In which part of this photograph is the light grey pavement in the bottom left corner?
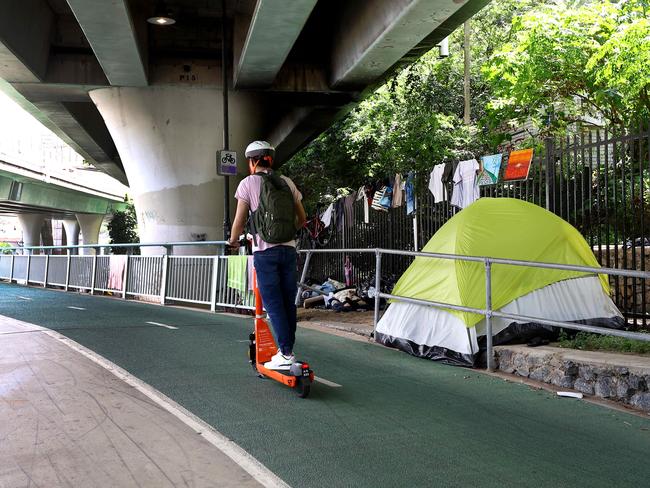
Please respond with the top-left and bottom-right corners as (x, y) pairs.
(0, 317), (268, 488)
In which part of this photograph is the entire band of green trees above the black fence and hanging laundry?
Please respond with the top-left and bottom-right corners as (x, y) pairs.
(285, 0), (650, 209)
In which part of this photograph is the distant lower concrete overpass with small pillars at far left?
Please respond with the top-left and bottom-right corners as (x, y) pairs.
(0, 161), (125, 252)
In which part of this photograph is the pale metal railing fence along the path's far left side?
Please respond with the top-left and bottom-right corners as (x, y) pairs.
(0, 241), (255, 311)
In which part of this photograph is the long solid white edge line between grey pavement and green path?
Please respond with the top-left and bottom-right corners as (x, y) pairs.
(36, 324), (291, 488)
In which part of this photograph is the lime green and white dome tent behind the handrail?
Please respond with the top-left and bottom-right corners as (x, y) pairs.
(377, 198), (620, 366)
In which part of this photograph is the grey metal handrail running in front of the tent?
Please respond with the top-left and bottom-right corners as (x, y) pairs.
(296, 248), (650, 371)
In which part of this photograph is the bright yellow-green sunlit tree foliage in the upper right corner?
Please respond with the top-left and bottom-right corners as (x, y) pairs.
(483, 0), (650, 131)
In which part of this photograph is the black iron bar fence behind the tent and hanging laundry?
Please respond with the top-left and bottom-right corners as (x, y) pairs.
(299, 127), (650, 326)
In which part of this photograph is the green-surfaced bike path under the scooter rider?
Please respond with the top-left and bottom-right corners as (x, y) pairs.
(0, 284), (650, 488)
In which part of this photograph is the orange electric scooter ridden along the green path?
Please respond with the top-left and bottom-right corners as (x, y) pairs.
(248, 268), (314, 398)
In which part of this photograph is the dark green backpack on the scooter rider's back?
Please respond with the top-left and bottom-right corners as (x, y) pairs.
(251, 172), (296, 244)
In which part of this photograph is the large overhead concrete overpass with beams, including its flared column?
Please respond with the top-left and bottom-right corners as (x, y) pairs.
(0, 0), (489, 250)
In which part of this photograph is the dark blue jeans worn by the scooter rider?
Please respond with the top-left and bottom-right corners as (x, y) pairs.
(253, 246), (298, 354)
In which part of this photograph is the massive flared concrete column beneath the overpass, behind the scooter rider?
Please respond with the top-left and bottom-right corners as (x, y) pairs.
(90, 85), (264, 254)
